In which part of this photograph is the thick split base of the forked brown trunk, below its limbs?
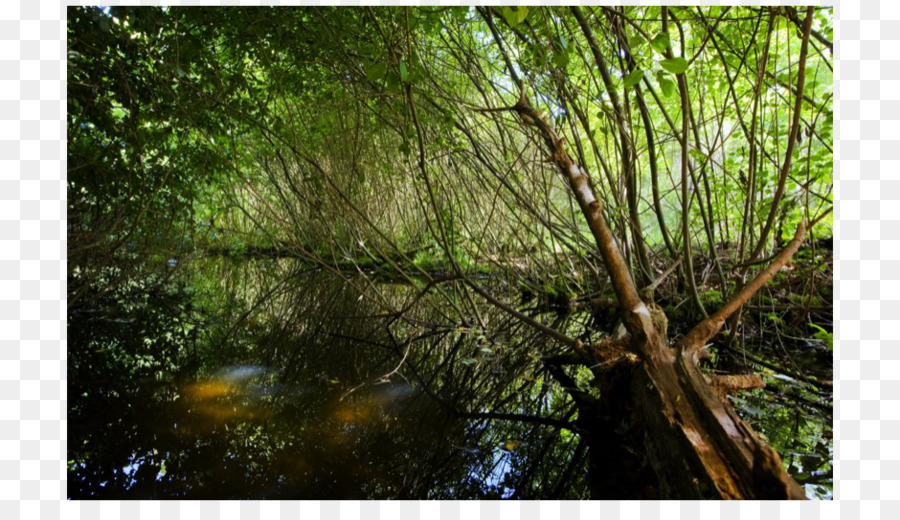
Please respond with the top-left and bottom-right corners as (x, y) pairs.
(582, 335), (805, 500)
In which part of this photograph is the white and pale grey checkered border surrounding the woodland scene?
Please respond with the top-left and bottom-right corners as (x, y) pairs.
(0, 0), (864, 520)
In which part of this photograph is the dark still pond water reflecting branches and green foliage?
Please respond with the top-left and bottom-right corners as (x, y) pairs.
(68, 259), (831, 499)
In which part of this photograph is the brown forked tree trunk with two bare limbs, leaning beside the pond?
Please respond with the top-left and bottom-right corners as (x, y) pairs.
(510, 85), (805, 499)
